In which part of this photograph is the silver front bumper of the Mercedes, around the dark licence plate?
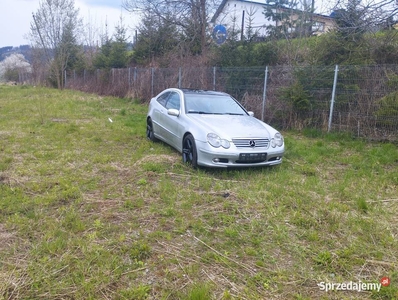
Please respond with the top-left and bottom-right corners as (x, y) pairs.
(196, 141), (284, 168)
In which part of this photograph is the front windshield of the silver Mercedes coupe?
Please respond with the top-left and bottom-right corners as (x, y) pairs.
(185, 94), (247, 115)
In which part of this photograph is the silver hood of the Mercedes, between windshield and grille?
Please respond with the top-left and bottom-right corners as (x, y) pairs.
(188, 114), (271, 139)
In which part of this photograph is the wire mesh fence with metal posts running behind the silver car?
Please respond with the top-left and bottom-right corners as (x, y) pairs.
(65, 65), (398, 141)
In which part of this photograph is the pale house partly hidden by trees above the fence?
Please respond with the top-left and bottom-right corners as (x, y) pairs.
(210, 0), (335, 39)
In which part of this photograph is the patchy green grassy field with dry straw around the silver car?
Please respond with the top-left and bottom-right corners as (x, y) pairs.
(0, 86), (398, 299)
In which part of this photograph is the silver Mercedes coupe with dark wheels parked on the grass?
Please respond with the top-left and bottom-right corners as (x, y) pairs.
(146, 88), (284, 167)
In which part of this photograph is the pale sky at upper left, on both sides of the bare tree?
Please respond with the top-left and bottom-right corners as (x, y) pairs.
(0, 0), (137, 48)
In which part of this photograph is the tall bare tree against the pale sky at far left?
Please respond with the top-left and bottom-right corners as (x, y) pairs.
(30, 0), (82, 88)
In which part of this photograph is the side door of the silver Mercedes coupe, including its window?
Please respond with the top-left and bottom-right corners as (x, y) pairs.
(162, 92), (181, 149)
